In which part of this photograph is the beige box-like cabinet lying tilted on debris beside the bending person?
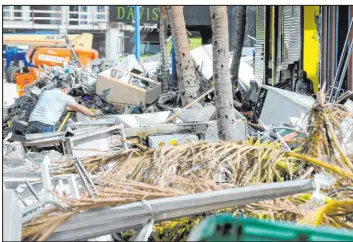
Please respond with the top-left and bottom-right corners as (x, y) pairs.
(96, 67), (161, 106)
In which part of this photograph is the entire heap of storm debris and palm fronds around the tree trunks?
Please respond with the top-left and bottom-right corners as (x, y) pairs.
(3, 42), (353, 241)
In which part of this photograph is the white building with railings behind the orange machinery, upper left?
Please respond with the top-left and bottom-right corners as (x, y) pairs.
(3, 6), (109, 56)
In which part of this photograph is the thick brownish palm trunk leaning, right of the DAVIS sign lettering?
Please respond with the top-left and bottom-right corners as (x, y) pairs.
(167, 6), (199, 106)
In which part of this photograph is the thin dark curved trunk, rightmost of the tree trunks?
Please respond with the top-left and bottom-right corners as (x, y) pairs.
(231, 6), (246, 88)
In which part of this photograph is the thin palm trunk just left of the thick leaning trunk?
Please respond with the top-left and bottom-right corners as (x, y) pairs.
(159, 6), (170, 93)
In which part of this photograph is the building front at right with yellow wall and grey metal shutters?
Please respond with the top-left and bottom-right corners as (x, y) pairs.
(254, 6), (353, 91)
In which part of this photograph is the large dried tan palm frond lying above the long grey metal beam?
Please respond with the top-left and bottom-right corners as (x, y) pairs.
(99, 141), (353, 187)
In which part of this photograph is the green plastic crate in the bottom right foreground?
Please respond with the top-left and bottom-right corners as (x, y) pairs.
(188, 214), (353, 241)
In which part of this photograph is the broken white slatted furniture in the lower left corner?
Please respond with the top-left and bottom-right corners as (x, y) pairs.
(3, 156), (85, 238)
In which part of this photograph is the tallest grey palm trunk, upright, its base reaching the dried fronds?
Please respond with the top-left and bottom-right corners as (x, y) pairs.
(211, 6), (236, 140)
